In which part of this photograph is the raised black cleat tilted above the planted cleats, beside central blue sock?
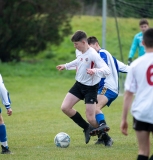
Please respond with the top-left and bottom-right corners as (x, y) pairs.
(90, 124), (110, 136)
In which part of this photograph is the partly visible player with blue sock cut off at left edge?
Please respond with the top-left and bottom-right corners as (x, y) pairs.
(0, 75), (12, 154)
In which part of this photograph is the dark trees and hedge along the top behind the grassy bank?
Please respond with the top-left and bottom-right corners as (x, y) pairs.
(0, 0), (153, 62)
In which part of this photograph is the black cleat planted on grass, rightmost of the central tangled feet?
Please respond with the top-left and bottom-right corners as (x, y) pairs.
(95, 132), (113, 147)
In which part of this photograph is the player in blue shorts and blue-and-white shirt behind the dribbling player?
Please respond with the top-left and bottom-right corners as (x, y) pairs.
(88, 36), (129, 146)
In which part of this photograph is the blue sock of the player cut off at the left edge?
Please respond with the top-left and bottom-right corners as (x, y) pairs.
(0, 124), (8, 148)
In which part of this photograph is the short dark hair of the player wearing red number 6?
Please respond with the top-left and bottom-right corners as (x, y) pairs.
(143, 28), (153, 48)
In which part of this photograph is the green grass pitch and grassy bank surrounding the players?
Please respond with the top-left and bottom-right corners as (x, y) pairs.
(0, 16), (152, 160)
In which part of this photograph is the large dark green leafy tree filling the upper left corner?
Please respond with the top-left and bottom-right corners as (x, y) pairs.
(0, 0), (80, 62)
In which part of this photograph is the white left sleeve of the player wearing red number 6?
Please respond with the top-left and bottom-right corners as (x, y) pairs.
(124, 67), (137, 93)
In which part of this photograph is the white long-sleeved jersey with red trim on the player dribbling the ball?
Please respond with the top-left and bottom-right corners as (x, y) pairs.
(65, 47), (110, 86)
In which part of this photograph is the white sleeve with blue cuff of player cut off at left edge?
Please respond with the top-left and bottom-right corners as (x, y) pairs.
(0, 74), (11, 109)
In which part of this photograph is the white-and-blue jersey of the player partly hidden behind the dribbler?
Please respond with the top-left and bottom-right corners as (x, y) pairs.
(98, 49), (129, 94)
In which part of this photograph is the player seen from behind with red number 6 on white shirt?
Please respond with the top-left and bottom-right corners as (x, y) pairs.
(121, 28), (153, 160)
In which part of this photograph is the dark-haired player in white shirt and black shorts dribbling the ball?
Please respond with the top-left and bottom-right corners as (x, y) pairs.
(56, 31), (110, 144)
